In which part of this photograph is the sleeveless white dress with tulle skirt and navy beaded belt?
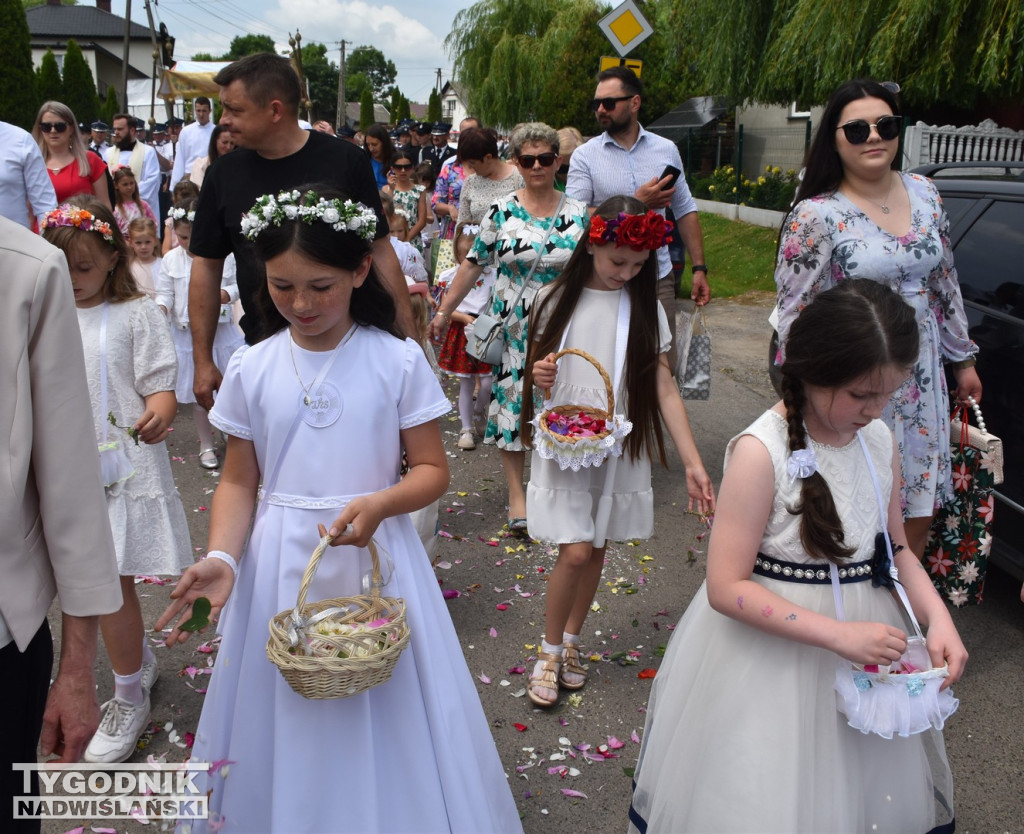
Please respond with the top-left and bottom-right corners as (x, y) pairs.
(629, 411), (952, 834)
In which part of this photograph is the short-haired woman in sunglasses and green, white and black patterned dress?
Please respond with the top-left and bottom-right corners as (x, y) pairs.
(430, 122), (587, 535)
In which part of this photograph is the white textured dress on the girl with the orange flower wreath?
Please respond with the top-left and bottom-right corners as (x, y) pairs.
(78, 298), (193, 576)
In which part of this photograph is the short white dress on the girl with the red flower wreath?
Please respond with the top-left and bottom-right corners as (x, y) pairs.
(526, 287), (672, 544)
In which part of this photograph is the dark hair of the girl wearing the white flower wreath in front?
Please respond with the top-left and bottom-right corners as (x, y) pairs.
(254, 183), (402, 340)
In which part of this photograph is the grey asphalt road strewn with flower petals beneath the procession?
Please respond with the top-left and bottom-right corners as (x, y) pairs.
(37, 295), (1024, 834)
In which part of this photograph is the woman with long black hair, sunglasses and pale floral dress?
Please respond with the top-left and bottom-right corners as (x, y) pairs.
(775, 80), (981, 569)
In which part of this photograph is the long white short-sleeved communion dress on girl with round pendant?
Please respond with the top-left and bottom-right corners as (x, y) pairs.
(193, 327), (521, 834)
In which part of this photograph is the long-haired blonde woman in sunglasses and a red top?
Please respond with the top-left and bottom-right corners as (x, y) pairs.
(32, 101), (111, 208)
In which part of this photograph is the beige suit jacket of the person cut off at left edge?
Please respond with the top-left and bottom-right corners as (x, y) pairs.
(0, 217), (121, 651)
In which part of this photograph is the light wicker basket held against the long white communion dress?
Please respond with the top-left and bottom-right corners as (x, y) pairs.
(266, 536), (411, 699)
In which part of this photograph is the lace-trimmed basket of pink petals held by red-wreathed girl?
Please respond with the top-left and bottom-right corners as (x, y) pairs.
(534, 347), (633, 471)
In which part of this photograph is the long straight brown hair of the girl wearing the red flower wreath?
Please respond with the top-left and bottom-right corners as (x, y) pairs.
(520, 196), (666, 465)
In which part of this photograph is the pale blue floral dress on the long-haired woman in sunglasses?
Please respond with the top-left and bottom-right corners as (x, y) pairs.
(775, 173), (978, 518)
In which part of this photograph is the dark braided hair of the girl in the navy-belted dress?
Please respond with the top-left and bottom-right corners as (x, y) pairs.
(781, 280), (920, 561)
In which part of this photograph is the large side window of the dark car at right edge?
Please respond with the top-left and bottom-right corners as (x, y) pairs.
(946, 198), (1024, 309)
